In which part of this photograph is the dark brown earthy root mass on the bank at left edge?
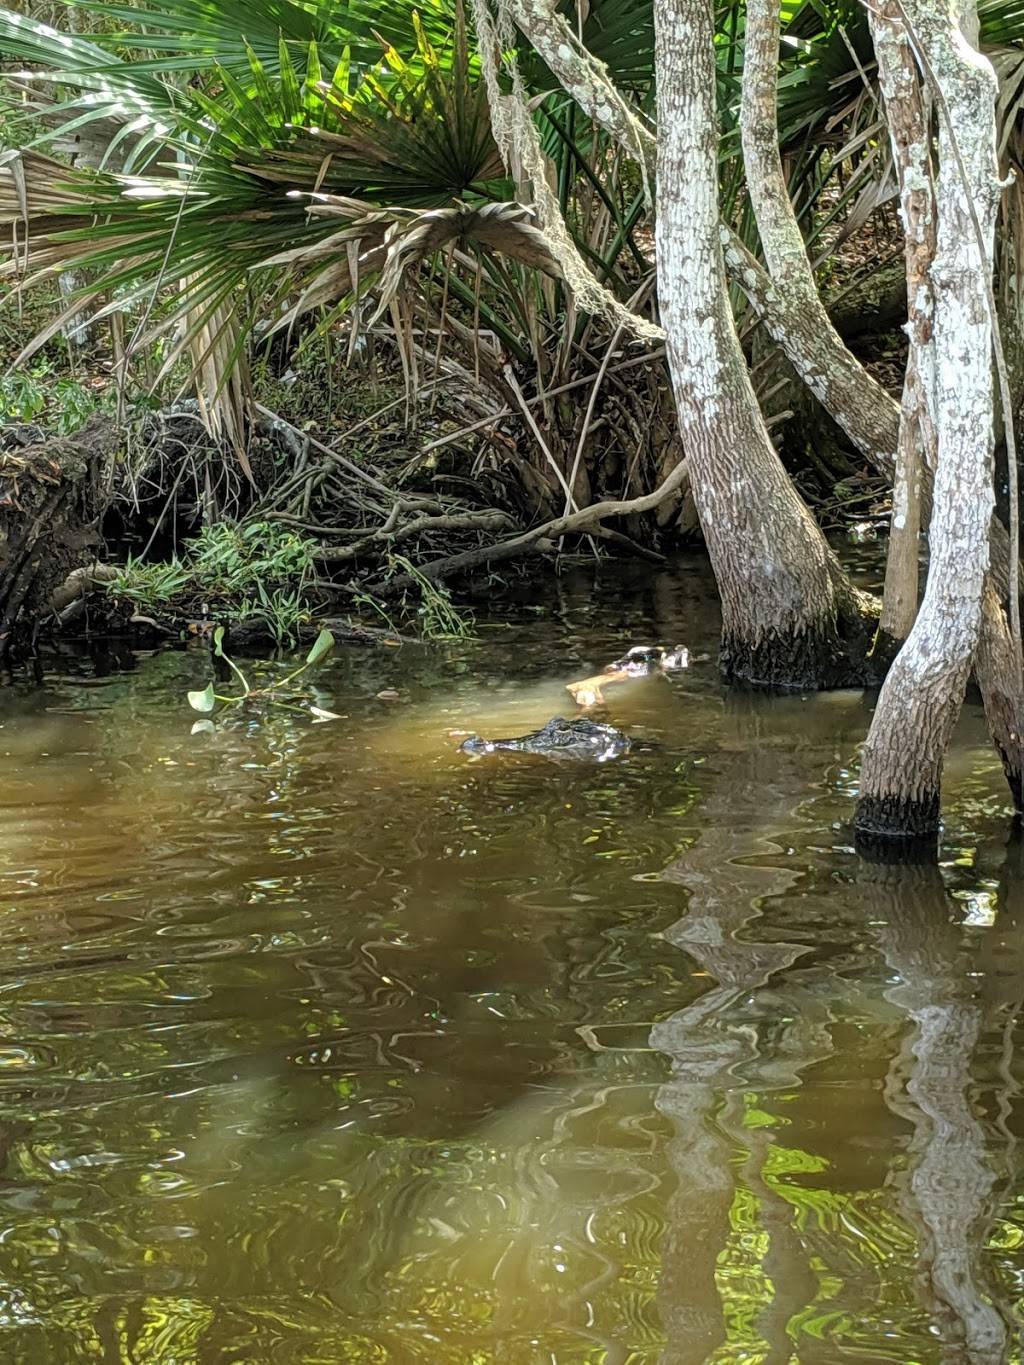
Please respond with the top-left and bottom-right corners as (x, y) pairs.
(0, 414), (119, 658)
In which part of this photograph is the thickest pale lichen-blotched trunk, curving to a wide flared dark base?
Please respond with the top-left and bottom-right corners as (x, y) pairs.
(654, 0), (867, 687)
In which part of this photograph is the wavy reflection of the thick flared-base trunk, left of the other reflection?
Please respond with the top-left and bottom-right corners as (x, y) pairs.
(651, 745), (831, 1365)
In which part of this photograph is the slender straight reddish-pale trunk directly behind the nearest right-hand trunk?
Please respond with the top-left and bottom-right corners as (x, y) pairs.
(868, 0), (935, 655)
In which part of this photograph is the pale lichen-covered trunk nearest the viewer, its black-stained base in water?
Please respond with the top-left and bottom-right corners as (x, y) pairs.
(855, 0), (999, 837)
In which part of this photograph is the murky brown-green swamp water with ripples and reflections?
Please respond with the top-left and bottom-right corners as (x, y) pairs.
(0, 564), (1024, 1365)
